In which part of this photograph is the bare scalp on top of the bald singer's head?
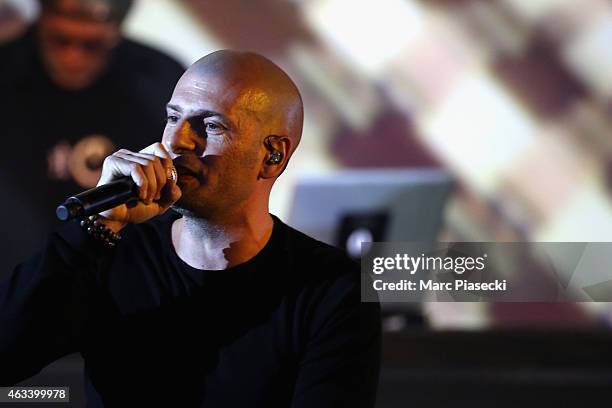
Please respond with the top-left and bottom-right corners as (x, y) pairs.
(181, 50), (304, 154)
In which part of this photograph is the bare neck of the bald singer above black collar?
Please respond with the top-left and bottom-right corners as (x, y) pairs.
(172, 212), (274, 270)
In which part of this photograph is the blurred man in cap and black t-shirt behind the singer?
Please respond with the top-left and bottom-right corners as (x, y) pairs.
(0, 0), (184, 278)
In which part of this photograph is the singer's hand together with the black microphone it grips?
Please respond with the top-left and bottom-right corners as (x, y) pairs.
(57, 143), (181, 231)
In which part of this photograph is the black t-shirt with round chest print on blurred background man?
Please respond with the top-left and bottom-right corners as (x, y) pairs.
(0, 30), (184, 278)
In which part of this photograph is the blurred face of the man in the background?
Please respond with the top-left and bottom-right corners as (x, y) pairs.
(39, 14), (120, 90)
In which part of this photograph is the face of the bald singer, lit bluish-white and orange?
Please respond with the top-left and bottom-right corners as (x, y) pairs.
(163, 72), (266, 217)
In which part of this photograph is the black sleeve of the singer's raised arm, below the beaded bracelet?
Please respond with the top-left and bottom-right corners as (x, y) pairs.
(0, 222), (112, 386)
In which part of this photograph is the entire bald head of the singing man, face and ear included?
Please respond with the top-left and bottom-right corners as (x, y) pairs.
(162, 51), (304, 218)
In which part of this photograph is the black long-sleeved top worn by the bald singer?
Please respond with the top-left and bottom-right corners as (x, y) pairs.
(0, 212), (380, 408)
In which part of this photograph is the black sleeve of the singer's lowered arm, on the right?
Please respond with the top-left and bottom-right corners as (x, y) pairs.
(293, 262), (381, 408)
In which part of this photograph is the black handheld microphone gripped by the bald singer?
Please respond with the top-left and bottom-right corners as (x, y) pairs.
(55, 166), (178, 221)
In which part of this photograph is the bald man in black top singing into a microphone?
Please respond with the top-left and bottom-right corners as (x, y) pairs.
(0, 51), (380, 408)
